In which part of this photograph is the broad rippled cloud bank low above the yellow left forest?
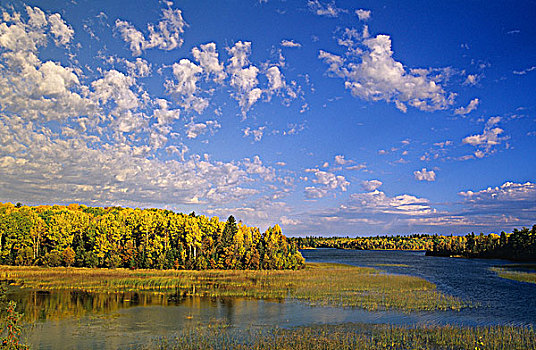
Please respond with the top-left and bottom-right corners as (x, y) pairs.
(0, 115), (271, 206)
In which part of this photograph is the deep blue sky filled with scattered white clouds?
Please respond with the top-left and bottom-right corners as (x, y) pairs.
(0, 0), (536, 236)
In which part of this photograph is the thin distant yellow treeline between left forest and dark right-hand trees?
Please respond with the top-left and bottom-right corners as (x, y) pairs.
(291, 234), (437, 250)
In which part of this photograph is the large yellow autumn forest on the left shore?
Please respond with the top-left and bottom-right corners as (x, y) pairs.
(0, 203), (304, 270)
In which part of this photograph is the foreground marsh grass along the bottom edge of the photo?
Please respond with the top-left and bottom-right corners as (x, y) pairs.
(142, 323), (536, 350)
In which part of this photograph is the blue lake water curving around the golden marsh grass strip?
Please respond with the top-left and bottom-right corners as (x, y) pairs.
(8, 249), (536, 349)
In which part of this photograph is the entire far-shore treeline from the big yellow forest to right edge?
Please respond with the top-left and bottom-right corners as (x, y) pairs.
(291, 225), (536, 261)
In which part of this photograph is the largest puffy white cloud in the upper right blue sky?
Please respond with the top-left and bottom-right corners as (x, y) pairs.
(319, 35), (454, 112)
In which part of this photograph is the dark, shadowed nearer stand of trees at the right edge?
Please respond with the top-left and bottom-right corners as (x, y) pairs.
(426, 225), (536, 261)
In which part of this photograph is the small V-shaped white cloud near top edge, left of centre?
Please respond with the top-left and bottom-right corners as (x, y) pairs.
(115, 3), (187, 56)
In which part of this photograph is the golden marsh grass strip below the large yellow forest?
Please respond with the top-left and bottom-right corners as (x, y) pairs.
(0, 263), (467, 311)
